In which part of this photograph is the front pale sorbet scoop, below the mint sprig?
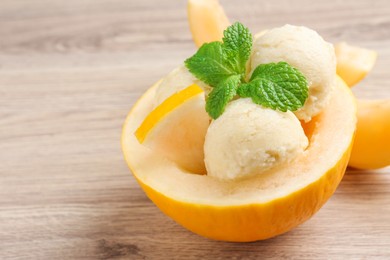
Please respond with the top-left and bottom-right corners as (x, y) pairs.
(204, 98), (308, 180)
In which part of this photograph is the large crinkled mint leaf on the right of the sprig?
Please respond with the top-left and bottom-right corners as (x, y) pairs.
(238, 62), (308, 112)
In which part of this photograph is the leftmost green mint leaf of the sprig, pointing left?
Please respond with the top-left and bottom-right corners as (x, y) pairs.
(184, 42), (236, 87)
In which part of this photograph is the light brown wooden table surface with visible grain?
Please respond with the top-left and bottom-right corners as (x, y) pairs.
(0, 0), (390, 259)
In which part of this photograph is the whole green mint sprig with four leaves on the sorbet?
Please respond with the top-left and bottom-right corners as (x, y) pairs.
(185, 22), (308, 119)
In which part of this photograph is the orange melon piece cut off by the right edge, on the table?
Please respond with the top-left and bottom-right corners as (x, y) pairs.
(349, 99), (390, 169)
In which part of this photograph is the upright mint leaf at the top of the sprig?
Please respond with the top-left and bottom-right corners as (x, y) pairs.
(223, 22), (252, 78)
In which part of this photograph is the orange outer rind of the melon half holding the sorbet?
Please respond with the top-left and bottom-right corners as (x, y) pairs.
(134, 146), (352, 242)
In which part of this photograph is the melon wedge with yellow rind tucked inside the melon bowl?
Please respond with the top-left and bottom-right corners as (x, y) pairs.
(134, 84), (210, 174)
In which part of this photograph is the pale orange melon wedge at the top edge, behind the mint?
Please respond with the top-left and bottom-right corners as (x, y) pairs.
(187, 0), (230, 47)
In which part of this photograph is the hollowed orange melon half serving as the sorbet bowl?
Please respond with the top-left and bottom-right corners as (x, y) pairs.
(122, 75), (356, 242)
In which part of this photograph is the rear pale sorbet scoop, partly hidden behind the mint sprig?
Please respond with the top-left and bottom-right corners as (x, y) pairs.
(250, 25), (336, 121)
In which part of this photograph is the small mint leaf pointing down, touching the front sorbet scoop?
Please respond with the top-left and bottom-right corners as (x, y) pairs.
(206, 75), (240, 119)
